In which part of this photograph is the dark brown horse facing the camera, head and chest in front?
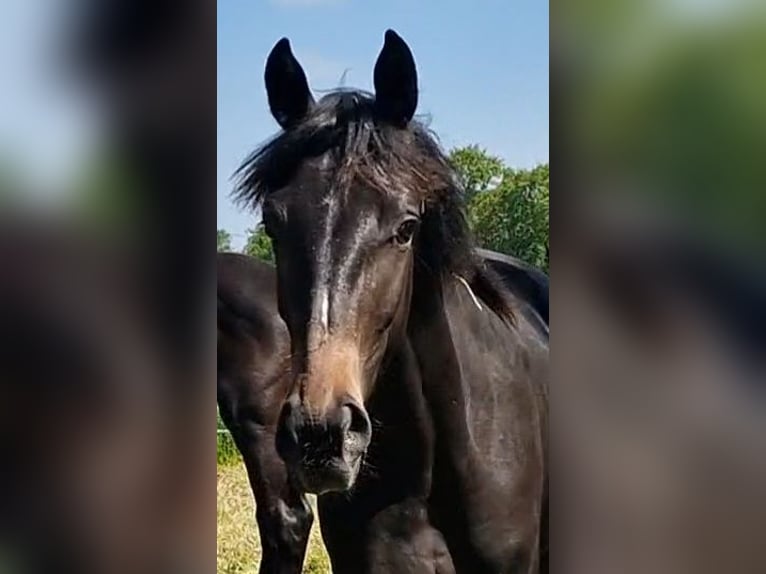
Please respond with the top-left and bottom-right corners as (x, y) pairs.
(230, 30), (548, 574)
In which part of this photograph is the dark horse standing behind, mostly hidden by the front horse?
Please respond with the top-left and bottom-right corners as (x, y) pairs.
(217, 249), (548, 574)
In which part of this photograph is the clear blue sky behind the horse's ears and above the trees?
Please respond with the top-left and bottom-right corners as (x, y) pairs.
(217, 0), (548, 247)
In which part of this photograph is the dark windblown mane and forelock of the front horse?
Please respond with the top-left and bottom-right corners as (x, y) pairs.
(233, 89), (514, 322)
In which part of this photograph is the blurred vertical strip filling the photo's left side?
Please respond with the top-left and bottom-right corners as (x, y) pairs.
(0, 0), (216, 574)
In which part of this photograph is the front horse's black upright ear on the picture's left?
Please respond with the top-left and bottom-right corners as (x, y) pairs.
(264, 38), (314, 129)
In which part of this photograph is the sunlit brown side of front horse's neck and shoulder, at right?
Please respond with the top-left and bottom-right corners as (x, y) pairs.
(428, 284), (548, 573)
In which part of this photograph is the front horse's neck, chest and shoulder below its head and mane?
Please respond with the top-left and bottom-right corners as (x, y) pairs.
(319, 272), (547, 574)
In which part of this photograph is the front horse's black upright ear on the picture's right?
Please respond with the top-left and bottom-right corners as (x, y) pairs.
(373, 30), (418, 127)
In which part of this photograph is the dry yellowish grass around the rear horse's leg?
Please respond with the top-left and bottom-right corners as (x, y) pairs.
(217, 452), (331, 574)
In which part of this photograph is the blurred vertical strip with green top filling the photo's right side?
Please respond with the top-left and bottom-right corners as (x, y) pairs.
(551, 0), (766, 574)
